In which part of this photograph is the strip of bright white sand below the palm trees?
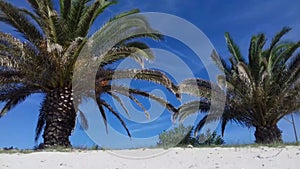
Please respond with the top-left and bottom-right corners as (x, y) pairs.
(0, 146), (300, 169)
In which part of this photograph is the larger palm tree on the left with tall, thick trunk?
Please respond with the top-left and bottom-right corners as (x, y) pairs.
(0, 0), (176, 147)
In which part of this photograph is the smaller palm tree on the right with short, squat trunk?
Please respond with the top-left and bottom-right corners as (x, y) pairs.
(175, 27), (300, 143)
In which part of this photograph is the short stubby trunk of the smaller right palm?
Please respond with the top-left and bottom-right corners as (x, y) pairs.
(254, 125), (282, 144)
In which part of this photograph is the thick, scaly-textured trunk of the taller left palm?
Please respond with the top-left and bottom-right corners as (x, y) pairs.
(43, 88), (76, 147)
